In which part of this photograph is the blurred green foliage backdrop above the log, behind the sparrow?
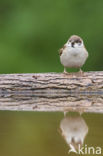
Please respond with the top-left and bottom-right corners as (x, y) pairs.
(0, 0), (103, 73)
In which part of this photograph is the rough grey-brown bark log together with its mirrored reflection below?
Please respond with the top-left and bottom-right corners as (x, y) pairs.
(0, 72), (103, 113)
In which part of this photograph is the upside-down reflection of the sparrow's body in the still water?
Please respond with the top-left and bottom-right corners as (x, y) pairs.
(60, 116), (88, 152)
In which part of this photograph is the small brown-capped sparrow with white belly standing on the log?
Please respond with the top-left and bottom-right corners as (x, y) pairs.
(59, 35), (88, 73)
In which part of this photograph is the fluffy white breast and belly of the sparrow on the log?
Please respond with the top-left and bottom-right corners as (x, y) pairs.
(60, 47), (88, 68)
